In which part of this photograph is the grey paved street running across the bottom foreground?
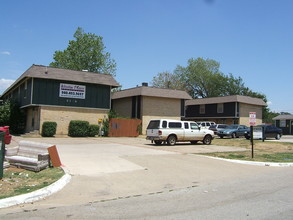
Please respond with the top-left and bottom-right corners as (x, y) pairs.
(8, 168), (293, 220)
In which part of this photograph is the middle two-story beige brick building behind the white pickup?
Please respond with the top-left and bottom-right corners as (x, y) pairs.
(112, 83), (191, 134)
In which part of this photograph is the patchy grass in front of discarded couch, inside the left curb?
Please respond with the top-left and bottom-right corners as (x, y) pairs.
(0, 167), (64, 199)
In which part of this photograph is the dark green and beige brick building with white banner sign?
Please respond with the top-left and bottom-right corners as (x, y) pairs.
(1, 65), (119, 135)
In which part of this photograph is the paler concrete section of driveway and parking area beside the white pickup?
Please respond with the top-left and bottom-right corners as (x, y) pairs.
(8, 137), (243, 176)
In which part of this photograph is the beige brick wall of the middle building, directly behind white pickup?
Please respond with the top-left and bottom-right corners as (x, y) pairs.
(141, 96), (181, 134)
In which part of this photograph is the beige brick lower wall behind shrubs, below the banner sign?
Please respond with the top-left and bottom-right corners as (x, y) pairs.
(40, 106), (109, 135)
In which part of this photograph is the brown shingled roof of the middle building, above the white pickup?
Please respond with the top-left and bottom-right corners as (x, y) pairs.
(112, 86), (192, 99)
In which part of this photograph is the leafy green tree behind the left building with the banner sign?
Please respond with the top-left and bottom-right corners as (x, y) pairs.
(50, 27), (116, 76)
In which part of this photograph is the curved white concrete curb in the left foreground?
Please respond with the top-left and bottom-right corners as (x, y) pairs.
(0, 168), (71, 209)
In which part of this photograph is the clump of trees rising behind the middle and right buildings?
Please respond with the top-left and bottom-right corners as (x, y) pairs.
(152, 58), (274, 122)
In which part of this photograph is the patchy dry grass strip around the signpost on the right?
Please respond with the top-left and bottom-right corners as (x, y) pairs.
(204, 138), (293, 163)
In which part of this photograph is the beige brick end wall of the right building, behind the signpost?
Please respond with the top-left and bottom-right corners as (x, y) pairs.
(239, 103), (262, 126)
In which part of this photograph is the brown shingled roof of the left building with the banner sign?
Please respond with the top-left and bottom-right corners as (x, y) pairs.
(3, 64), (120, 94)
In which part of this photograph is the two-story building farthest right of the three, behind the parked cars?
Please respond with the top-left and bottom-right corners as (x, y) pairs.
(185, 95), (266, 125)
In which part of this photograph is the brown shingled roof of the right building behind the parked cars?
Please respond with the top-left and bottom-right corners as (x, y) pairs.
(185, 95), (267, 106)
